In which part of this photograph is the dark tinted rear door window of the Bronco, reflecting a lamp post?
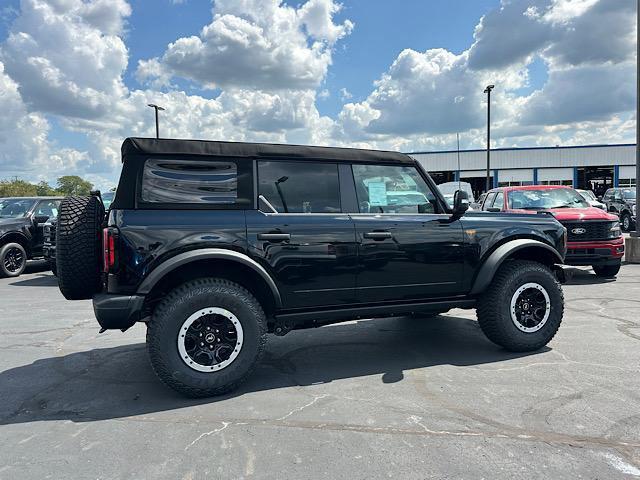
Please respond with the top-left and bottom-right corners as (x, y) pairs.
(258, 162), (340, 213)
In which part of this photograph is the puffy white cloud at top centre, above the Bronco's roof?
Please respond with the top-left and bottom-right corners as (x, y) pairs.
(137, 0), (353, 90)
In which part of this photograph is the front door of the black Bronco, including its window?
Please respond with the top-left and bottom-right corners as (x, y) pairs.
(352, 164), (464, 303)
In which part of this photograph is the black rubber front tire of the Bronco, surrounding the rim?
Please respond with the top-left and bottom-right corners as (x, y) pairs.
(477, 260), (564, 352)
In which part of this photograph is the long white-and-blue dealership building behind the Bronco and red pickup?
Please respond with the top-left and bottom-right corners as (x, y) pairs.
(409, 144), (636, 198)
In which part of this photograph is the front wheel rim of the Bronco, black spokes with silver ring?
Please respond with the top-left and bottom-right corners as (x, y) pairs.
(509, 282), (551, 333)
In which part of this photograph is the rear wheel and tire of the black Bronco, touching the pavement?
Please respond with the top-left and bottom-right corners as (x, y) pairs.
(147, 278), (267, 398)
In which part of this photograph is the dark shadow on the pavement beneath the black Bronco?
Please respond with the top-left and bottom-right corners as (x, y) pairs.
(0, 315), (550, 425)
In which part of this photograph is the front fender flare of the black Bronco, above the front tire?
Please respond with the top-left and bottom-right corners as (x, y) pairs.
(469, 238), (563, 295)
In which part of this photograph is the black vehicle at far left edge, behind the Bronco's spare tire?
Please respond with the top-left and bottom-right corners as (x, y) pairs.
(0, 197), (62, 277)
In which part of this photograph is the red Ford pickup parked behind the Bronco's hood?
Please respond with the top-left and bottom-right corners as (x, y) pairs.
(482, 185), (624, 278)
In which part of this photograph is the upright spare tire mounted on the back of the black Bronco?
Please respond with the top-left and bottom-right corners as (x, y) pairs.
(56, 196), (104, 300)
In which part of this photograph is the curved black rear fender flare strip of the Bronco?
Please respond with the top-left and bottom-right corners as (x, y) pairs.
(136, 248), (282, 308)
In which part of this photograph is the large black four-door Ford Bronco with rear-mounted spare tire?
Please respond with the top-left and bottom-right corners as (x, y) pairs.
(57, 138), (566, 397)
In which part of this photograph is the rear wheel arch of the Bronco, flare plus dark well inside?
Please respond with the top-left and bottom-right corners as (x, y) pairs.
(137, 248), (282, 315)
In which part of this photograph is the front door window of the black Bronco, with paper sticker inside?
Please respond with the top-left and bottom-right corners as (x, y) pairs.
(353, 165), (436, 213)
